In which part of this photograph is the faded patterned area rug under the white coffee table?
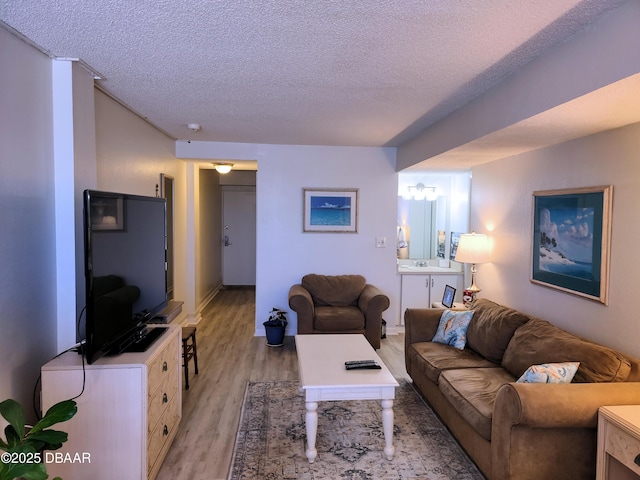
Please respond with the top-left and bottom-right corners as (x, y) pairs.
(229, 381), (484, 480)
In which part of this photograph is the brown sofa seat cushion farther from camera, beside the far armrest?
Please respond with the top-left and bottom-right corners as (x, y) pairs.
(408, 342), (495, 383)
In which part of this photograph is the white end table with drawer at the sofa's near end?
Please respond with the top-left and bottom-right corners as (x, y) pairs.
(596, 405), (640, 480)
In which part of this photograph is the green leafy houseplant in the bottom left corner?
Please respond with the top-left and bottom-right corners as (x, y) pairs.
(0, 399), (78, 480)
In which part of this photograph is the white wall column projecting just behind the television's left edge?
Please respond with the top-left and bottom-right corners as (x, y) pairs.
(51, 60), (96, 352)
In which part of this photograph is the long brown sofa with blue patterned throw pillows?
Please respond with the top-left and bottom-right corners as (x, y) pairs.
(405, 299), (640, 480)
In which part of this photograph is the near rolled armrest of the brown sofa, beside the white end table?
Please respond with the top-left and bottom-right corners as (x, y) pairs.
(491, 382), (640, 480)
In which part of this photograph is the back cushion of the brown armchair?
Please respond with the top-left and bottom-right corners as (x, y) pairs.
(301, 274), (367, 307)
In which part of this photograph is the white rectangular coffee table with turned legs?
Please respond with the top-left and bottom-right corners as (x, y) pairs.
(295, 334), (398, 463)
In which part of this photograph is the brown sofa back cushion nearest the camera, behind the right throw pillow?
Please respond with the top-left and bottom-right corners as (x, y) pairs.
(502, 319), (631, 383)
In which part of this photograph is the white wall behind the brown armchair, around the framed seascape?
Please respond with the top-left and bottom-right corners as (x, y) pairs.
(176, 142), (400, 335)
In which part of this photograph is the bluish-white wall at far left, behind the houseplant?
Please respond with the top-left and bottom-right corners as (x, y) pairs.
(0, 28), (57, 408)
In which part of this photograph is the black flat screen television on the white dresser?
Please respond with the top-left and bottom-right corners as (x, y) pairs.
(84, 190), (167, 363)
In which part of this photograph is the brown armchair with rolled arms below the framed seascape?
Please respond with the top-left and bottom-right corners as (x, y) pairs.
(289, 274), (389, 348)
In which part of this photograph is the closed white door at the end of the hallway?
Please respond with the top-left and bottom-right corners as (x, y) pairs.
(222, 187), (256, 285)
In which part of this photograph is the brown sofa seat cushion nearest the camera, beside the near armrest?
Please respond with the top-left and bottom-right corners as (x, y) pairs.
(438, 367), (515, 440)
